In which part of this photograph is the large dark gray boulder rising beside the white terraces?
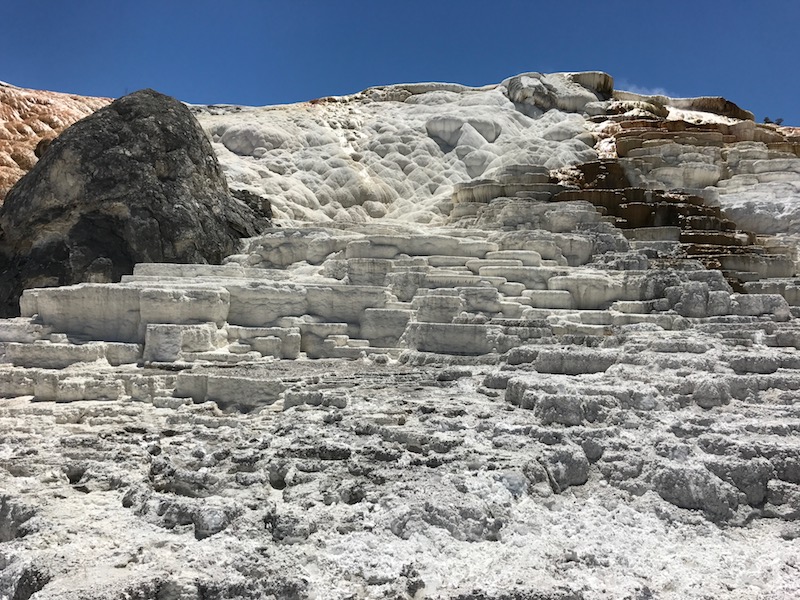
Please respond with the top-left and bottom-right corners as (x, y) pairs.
(0, 90), (271, 316)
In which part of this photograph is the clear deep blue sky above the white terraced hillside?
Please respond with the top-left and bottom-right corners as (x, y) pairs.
(0, 0), (800, 125)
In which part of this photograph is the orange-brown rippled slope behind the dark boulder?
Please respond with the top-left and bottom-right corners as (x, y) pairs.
(0, 83), (111, 203)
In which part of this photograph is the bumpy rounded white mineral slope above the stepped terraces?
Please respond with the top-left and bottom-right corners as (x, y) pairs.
(197, 73), (611, 223)
